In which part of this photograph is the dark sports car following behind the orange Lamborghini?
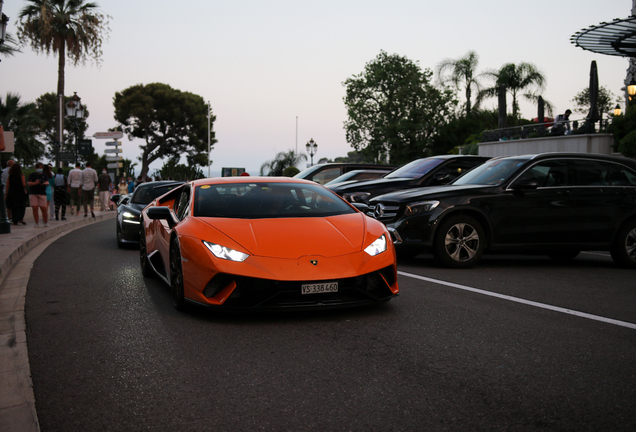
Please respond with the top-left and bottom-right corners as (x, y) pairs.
(110, 181), (183, 247)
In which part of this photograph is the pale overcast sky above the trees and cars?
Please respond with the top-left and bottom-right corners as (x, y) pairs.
(0, 0), (632, 175)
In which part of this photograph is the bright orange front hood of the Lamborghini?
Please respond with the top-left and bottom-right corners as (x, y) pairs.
(201, 213), (366, 259)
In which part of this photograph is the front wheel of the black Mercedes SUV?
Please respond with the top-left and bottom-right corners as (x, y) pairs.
(433, 215), (486, 268)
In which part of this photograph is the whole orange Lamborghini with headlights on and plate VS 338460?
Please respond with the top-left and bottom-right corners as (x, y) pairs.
(140, 177), (399, 309)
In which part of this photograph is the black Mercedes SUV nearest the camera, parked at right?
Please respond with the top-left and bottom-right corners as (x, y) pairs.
(368, 153), (636, 268)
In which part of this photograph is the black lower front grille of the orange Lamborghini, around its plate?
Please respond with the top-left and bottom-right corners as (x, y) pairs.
(203, 266), (396, 309)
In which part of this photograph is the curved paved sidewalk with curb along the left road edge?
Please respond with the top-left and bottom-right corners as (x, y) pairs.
(0, 207), (117, 432)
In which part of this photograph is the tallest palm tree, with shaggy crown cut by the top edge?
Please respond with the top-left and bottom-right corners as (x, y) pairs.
(18, 0), (110, 145)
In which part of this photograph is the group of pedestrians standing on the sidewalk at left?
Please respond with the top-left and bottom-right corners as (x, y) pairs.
(2, 160), (112, 227)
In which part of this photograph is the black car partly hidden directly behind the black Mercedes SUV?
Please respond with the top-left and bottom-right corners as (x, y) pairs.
(327, 155), (490, 203)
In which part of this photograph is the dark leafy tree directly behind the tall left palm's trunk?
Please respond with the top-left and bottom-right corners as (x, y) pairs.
(35, 93), (89, 163)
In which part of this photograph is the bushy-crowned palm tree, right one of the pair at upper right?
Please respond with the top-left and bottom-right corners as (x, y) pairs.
(477, 62), (546, 118)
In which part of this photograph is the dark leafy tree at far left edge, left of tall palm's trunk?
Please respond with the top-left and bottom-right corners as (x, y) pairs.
(0, 93), (44, 166)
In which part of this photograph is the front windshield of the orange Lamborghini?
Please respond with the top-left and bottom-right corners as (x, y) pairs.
(193, 182), (355, 219)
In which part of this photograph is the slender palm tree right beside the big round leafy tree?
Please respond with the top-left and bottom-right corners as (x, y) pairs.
(436, 51), (484, 116)
